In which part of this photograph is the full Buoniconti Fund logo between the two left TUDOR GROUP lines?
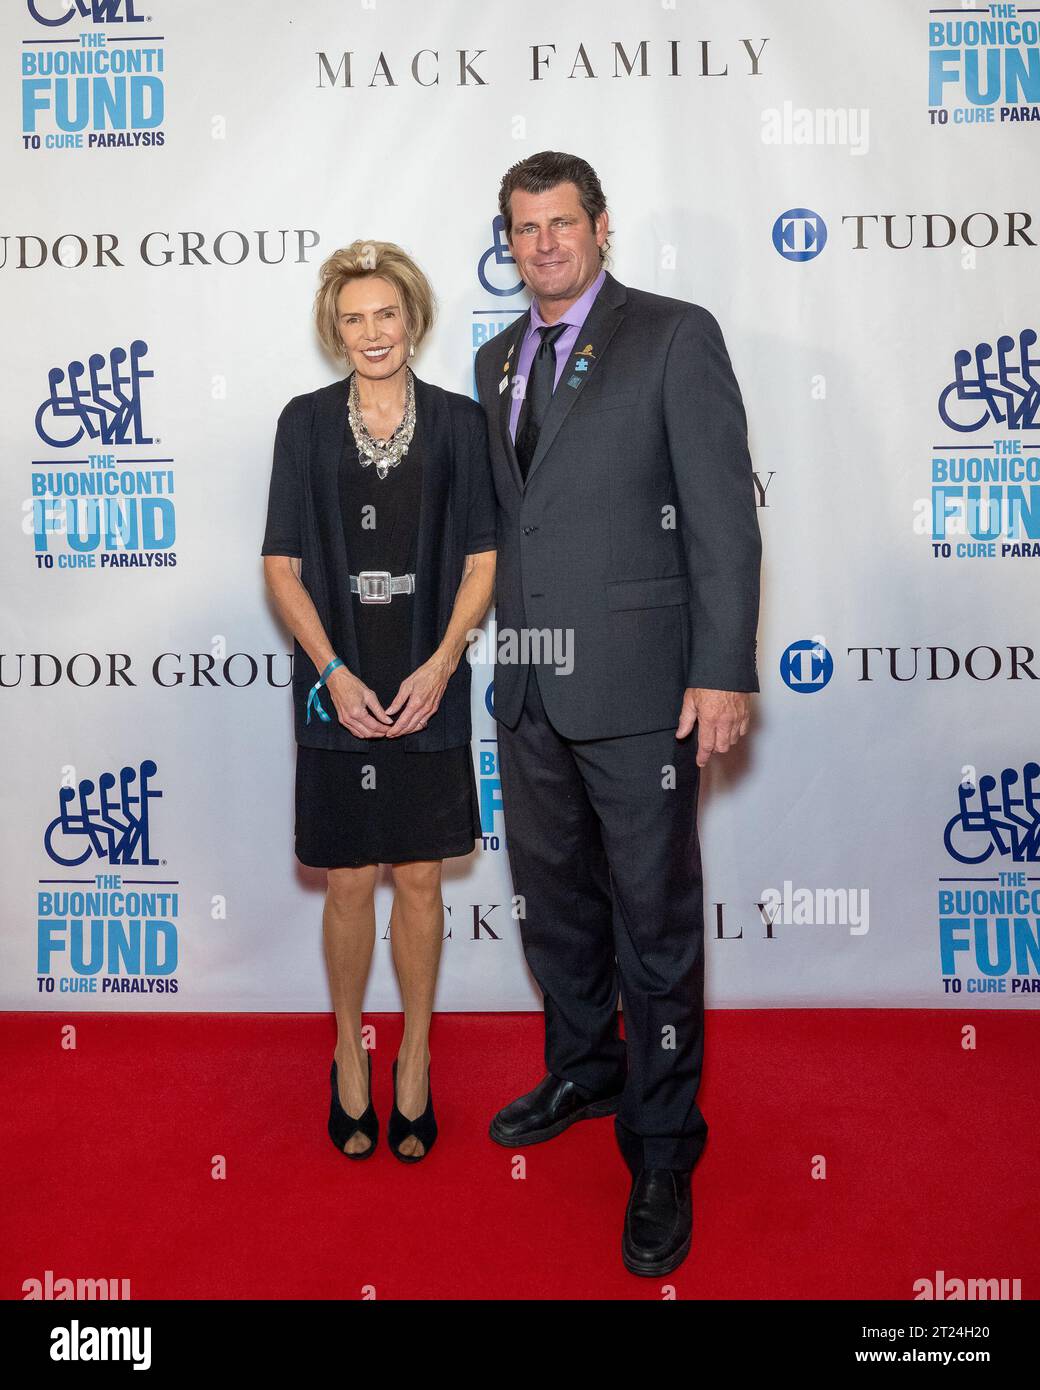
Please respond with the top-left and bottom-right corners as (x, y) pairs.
(25, 339), (177, 574)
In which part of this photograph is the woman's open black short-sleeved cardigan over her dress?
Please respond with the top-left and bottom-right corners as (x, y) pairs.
(260, 377), (495, 753)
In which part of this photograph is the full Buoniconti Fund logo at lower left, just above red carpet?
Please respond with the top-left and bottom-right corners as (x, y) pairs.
(36, 758), (181, 997)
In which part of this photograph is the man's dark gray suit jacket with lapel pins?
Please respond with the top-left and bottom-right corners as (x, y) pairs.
(476, 262), (762, 738)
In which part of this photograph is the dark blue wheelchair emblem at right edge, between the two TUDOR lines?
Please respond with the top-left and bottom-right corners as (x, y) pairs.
(939, 328), (1040, 434)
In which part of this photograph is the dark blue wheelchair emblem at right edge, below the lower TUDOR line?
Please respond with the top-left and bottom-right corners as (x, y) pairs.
(943, 763), (1040, 865)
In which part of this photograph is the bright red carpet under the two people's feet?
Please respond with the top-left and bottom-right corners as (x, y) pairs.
(0, 1009), (1040, 1300)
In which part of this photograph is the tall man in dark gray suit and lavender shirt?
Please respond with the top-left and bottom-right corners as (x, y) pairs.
(476, 152), (761, 1276)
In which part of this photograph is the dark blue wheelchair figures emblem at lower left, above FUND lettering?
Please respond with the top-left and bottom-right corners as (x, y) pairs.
(43, 759), (163, 869)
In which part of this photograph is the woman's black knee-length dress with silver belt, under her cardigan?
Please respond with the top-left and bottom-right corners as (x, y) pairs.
(296, 417), (481, 869)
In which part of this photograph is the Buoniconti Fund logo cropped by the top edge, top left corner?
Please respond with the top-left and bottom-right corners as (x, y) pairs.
(20, 0), (165, 153)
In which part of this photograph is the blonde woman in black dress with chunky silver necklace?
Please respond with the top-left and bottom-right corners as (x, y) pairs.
(261, 242), (495, 1162)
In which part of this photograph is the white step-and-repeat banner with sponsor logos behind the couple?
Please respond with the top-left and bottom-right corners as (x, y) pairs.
(0, 0), (1040, 1011)
